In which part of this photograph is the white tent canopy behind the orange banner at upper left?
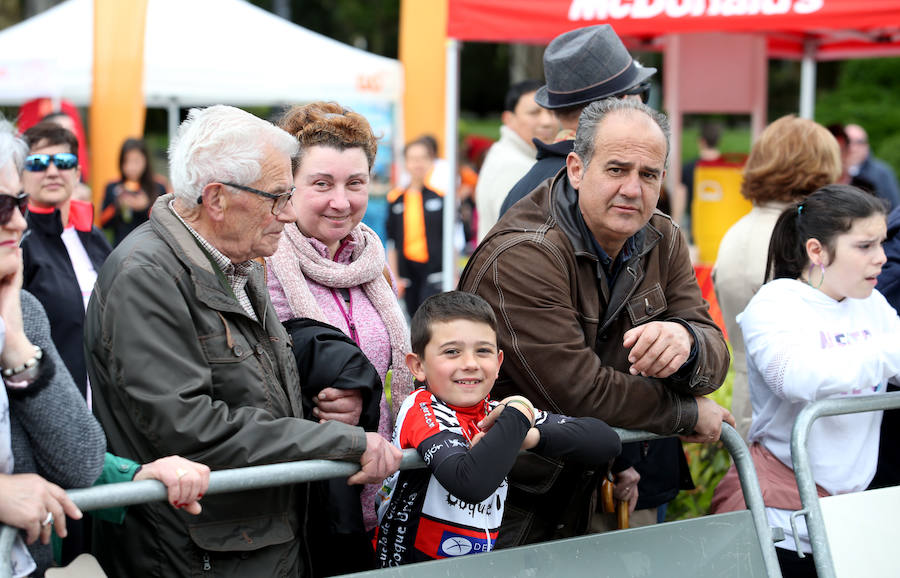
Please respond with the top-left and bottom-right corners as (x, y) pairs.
(0, 0), (403, 108)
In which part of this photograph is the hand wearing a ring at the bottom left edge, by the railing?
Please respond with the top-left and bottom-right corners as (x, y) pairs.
(0, 474), (81, 544)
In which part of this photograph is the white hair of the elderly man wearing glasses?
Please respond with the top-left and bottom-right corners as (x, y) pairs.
(169, 104), (299, 207)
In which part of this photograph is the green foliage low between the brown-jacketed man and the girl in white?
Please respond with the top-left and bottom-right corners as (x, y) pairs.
(666, 346), (734, 521)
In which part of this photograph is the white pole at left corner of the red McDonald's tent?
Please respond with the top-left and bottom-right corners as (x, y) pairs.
(441, 38), (459, 291)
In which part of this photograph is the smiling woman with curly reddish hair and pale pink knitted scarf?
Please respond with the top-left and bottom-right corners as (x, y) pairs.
(266, 102), (413, 576)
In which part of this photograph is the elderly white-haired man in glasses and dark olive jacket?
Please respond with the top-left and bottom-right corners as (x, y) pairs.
(85, 106), (400, 576)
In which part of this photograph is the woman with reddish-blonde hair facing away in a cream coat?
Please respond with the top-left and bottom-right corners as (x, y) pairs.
(713, 115), (841, 440)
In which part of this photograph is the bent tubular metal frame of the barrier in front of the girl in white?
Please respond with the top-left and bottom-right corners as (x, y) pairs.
(791, 392), (900, 578)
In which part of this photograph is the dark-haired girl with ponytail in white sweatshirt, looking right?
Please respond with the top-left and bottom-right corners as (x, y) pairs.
(713, 185), (900, 578)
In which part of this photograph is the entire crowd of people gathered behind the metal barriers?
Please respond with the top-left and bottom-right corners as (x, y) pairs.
(0, 15), (900, 576)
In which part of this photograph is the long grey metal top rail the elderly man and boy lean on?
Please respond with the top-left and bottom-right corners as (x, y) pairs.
(0, 424), (781, 578)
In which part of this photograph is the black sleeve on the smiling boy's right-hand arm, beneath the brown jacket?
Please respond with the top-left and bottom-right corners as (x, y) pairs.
(532, 412), (622, 466)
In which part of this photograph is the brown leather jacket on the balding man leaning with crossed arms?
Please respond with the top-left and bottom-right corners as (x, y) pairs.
(459, 171), (729, 434)
